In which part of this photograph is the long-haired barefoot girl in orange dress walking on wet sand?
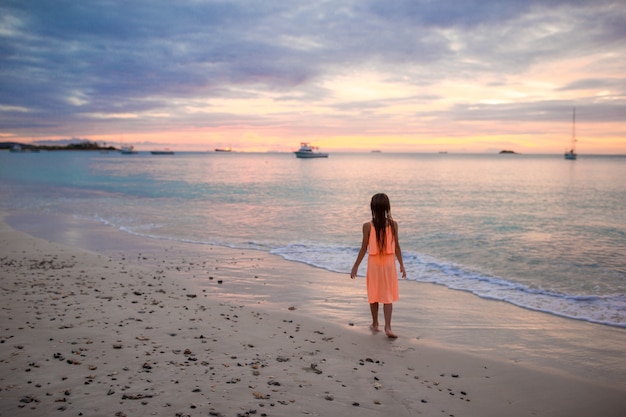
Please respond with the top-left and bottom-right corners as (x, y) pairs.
(350, 193), (406, 339)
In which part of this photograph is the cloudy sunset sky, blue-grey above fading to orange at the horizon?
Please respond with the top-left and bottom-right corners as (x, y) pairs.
(0, 0), (626, 154)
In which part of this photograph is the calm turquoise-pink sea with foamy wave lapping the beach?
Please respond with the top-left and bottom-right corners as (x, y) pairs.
(0, 152), (626, 328)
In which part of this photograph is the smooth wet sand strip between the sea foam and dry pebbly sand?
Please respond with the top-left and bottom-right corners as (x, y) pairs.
(5, 212), (626, 384)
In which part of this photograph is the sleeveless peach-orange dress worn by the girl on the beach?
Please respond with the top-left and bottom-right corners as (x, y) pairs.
(366, 222), (400, 304)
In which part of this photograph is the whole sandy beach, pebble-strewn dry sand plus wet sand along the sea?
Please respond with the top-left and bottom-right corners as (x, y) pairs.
(0, 214), (626, 417)
